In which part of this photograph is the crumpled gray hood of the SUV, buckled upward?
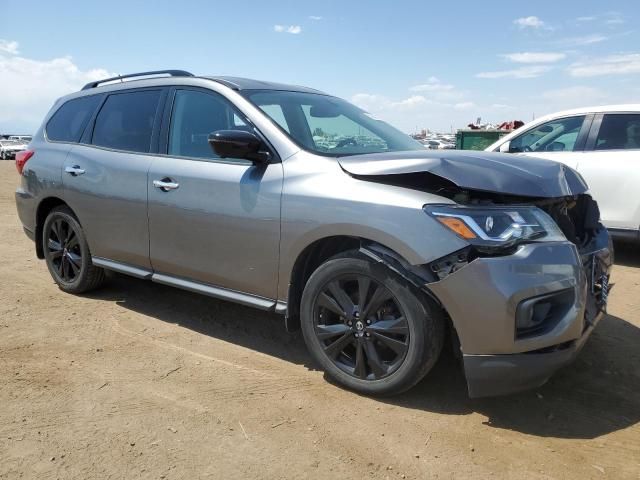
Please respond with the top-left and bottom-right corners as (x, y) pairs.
(338, 150), (588, 198)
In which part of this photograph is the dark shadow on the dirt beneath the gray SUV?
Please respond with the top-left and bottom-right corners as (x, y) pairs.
(90, 273), (640, 439)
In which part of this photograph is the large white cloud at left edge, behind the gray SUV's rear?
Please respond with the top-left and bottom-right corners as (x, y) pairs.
(0, 49), (114, 133)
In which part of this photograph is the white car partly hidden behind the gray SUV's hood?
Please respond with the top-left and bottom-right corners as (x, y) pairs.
(485, 104), (640, 240)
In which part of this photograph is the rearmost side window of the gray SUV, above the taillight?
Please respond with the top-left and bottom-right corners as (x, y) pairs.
(46, 95), (100, 142)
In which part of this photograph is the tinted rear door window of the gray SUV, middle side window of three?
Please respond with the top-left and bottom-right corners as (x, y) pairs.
(91, 90), (160, 152)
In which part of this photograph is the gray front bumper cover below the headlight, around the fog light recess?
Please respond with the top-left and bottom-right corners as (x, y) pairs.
(428, 242), (587, 355)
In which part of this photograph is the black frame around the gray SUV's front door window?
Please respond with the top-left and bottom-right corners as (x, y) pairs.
(156, 85), (281, 166)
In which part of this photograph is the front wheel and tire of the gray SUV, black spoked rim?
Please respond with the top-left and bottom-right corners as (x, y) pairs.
(300, 251), (444, 395)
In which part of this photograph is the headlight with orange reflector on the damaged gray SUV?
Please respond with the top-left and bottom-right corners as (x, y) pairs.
(424, 205), (565, 248)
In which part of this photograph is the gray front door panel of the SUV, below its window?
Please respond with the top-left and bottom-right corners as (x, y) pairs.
(147, 157), (282, 298)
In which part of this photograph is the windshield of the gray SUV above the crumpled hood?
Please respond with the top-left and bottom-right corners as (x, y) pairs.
(241, 90), (424, 157)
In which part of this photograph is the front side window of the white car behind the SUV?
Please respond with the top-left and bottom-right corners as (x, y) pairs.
(509, 115), (585, 153)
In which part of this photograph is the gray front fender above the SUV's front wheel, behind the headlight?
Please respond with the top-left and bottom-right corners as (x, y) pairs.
(278, 152), (468, 301)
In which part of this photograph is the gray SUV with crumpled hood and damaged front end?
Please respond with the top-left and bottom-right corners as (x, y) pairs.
(16, 70), (612, 396)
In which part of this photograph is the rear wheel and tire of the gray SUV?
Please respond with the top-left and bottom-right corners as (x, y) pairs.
(42, 206), (104, 293)
